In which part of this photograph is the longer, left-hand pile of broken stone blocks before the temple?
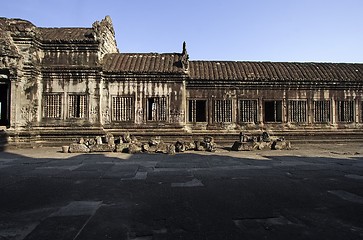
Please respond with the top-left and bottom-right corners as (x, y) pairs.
(62, 133), (216, 154)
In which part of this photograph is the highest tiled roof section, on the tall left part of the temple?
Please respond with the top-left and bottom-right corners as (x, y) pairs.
(38, 28), (95, 42)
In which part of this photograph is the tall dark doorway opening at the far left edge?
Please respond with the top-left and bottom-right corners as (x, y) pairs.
(0, 78), (10, 126)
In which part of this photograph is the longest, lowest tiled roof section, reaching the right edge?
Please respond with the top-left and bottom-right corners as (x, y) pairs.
(189, 61), (363, 81)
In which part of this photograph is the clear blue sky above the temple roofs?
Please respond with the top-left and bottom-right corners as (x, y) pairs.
(0, 0), (363, 63)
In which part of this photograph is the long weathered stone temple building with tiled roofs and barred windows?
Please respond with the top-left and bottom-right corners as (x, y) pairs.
(0, 16), (363, 145)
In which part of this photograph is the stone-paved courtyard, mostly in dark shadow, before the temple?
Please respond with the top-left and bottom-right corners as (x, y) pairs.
(0, 143), (363, 240)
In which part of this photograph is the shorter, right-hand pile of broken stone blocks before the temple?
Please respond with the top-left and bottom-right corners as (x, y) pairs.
(232, 132), (291, 151)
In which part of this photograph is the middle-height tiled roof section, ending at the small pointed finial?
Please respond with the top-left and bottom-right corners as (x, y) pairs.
(103, 53), (184, 74)
